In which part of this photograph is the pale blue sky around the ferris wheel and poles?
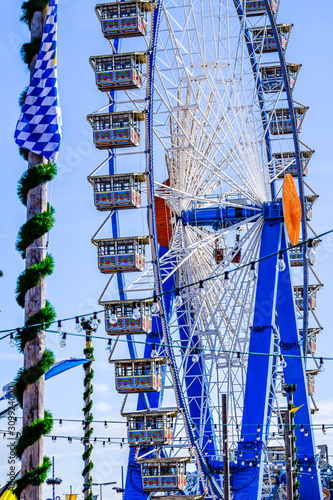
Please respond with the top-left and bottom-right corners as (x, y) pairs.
(0, 0), (333, 498)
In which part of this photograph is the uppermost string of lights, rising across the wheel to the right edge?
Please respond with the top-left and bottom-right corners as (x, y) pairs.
(0, 229), (333, 340)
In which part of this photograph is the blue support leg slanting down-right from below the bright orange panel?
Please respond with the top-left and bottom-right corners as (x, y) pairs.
(276, 230), (323, 500)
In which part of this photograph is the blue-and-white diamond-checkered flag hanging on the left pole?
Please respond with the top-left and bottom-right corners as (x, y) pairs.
(15, 0), (61, 162)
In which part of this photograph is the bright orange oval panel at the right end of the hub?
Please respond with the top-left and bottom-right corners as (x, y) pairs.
(283, 174), (302, 245)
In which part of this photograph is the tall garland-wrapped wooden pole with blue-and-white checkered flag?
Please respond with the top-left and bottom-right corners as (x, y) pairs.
(15, 0), (61, 500)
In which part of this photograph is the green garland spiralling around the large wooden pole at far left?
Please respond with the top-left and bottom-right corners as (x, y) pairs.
(14, 0), (57, 498)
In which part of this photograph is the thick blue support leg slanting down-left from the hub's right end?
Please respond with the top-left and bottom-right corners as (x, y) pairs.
(232, 219), (282, 500)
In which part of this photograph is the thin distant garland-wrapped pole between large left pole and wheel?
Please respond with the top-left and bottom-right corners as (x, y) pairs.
(81, 315), (99, 500)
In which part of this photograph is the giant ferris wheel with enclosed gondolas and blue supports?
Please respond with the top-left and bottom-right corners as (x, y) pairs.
(88, 0), (322, 500)
